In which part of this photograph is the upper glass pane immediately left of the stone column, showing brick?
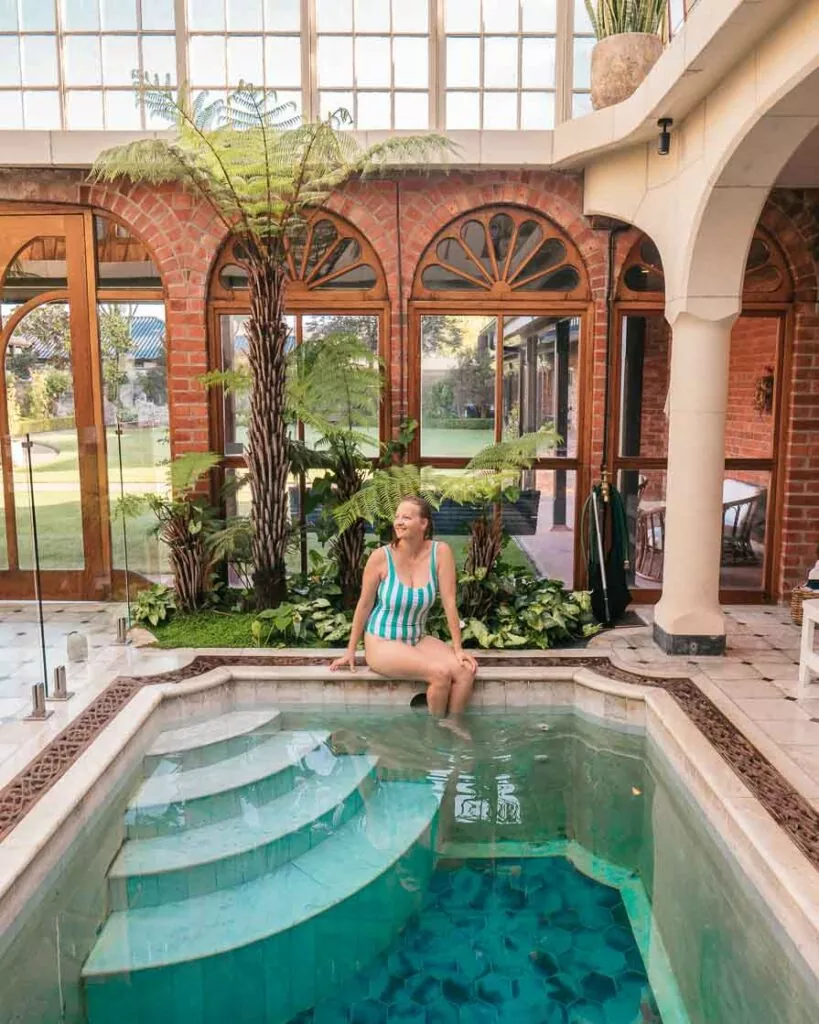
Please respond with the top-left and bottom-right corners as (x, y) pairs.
(619, 313), (671, 459)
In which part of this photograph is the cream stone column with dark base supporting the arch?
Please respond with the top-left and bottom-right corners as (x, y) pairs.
(654, 312), (736, 654)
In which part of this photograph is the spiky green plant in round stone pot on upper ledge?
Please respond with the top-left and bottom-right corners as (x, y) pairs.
(586, 0), (665, 111)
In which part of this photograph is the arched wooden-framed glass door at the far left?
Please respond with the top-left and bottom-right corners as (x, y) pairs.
(0, 210), (169, 598)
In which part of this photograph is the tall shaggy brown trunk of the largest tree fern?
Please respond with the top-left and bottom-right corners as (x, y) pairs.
(247, 254), (290, 609)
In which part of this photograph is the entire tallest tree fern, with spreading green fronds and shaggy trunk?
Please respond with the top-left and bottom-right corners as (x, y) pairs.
(91, 76), (449, 608)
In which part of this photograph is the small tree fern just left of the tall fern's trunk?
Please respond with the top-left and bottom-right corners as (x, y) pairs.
(115, 452), (219, 611)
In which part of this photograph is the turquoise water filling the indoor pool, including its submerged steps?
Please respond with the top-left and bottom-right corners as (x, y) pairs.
(0, 707), (819, 1024)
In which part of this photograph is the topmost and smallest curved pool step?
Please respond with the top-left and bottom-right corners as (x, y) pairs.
(145, 710), (282, 770)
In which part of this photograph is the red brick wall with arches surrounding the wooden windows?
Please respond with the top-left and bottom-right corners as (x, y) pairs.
(0, 170), (819, 592)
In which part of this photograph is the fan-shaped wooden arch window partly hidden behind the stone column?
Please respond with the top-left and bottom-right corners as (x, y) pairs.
(617, 227), (793, 303)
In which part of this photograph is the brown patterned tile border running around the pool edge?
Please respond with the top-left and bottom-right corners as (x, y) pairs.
(0, 654), (819, 869)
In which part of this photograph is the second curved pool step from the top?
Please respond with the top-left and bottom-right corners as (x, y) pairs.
(125, 730), (334, 839)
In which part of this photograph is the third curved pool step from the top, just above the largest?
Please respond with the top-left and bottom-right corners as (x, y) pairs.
(109, 757), (378, 910)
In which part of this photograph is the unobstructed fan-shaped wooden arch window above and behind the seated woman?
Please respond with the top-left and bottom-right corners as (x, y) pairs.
(413, 207), (589, 300)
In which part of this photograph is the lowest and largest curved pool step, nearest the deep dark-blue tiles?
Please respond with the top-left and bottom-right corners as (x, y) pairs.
(83, 782), (438, 1024)
